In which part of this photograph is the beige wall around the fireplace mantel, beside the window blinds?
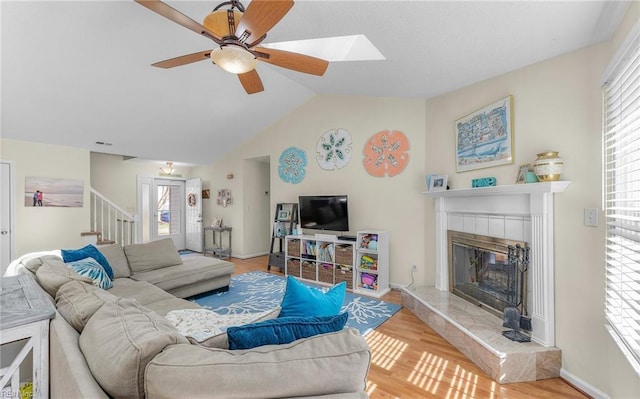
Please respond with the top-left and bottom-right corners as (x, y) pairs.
(422, 3), (640, 398)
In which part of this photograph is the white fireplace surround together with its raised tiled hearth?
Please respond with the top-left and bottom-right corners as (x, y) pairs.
(402, 181), (570, 383)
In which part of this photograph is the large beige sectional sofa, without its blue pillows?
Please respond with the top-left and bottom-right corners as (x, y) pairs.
(10, 242), (371, 399)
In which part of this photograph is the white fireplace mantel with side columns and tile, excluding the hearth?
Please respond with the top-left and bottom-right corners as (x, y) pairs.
(425, 181), (571, 346)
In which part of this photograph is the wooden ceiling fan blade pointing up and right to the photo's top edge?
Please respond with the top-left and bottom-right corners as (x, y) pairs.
(236, 0), (293, 43)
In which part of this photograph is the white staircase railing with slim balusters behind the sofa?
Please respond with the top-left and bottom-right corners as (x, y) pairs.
(80, 188), (137, 246)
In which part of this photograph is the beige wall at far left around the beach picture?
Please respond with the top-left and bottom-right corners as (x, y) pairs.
(0, 139), (90, 257)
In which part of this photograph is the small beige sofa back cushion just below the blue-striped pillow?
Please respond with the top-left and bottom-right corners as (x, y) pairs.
(56, 281), (118, 332)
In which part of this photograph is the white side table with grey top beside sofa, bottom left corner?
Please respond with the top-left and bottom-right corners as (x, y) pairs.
(0, 275), (56, 398)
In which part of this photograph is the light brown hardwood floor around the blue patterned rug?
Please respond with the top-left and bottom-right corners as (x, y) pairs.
(231, 256), (588, 399)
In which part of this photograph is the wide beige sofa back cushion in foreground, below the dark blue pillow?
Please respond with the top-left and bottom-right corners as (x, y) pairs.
(145, 328), (371, 399)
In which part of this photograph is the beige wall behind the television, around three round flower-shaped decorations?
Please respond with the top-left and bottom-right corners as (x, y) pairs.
(205, 95), (425, 284)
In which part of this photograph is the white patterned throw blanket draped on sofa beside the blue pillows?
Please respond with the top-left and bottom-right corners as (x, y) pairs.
(165, 307), (280, 342)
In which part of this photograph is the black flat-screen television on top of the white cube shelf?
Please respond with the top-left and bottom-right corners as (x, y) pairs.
(298, 195), (349, 231)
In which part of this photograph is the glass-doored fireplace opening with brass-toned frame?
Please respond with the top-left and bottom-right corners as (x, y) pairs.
(448, 231), (528, 317)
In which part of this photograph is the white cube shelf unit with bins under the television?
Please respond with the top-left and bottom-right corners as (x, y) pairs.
(285, 230), (389, 297)
